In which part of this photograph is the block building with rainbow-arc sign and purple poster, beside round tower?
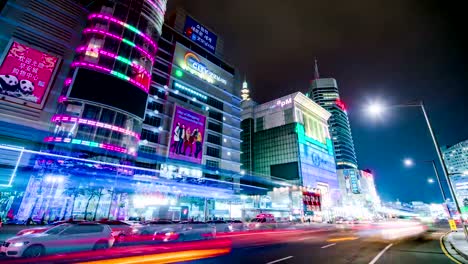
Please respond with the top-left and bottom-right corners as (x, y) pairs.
(138, 9), (241, 175)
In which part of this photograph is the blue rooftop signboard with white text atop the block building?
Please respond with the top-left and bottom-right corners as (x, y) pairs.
(184, 16), (218, 53)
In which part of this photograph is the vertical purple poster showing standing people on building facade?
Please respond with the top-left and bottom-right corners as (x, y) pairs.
(169, 105), (206, 164)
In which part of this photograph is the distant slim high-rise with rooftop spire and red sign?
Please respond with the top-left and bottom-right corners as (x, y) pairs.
(308, 61), (358, 169)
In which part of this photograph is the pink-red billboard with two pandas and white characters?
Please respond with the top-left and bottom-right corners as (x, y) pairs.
(0, 41), (60, 108)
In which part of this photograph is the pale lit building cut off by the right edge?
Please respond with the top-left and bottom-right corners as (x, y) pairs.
(441, 140), (468, 219)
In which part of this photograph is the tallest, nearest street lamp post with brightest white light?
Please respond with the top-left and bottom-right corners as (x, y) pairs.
(369, 101), (468, 239)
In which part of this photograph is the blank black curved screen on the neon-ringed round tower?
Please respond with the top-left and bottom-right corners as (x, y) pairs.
(68, 68), (148, 118)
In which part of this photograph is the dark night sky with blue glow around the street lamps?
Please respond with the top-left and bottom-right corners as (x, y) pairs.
(168, 0), (468, 202)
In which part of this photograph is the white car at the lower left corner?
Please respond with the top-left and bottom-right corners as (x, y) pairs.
(0, 223), (115, 258)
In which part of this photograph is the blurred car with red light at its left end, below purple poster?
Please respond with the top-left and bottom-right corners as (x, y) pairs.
(153, 221), (216, 242)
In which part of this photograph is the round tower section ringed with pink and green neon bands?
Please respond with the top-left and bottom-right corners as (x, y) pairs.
(48, 0), (166, 161)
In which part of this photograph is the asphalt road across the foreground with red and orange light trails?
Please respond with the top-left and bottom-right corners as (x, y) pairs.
(0, 224), (463, 264)
